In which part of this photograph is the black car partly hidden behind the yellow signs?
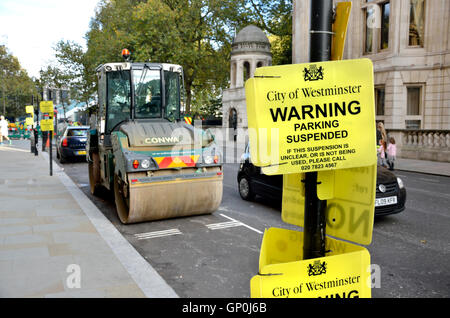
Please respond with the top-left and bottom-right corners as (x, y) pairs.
(237, 145), (406, 216)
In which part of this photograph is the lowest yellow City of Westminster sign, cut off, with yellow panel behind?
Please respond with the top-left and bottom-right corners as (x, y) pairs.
(250, 228), (371, 298)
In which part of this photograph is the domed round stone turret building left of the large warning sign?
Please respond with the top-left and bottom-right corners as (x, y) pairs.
(222, 25), (272, 140)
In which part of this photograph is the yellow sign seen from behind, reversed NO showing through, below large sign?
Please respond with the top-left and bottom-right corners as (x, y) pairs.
(281, 164), (377, 245)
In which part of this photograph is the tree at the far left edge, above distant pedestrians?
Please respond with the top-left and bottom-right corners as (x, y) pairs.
(0, 45), (37, 117)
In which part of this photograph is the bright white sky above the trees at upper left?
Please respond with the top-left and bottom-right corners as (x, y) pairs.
(0, 0), (99, 77)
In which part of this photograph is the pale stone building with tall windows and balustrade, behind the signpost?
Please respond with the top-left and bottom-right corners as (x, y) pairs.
(292, 0), (450, 161)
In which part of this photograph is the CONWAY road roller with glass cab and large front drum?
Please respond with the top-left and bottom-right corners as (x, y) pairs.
(86, 52), (223, 224)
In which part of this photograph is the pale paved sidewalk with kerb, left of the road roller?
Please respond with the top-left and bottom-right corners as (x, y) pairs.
(0, 141), (177, 297)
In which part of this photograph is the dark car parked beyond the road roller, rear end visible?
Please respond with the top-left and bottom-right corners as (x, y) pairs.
(56, 126), (89, 163)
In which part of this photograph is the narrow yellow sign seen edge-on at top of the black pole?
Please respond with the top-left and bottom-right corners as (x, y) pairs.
(331, 2), (352, 61)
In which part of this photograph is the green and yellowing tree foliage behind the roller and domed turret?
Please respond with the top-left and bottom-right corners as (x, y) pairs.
(51, 0), (292, 115)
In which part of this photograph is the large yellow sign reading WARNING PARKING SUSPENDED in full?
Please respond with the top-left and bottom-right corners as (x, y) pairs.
(245, 59), (377, 175)
